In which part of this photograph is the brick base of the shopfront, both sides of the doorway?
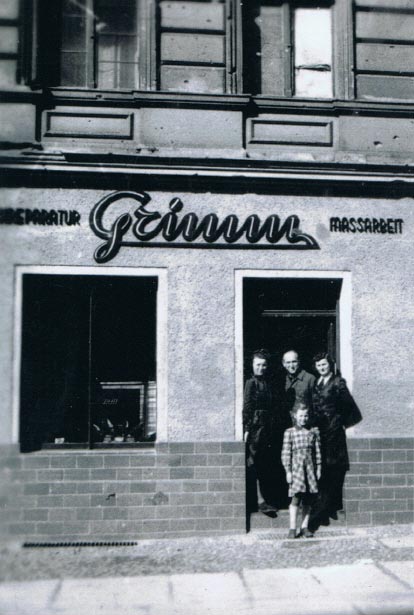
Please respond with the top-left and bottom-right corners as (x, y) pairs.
(0, 438), (414, 542)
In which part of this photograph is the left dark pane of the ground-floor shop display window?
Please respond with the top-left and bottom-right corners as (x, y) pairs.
(20, 274), (89, 451)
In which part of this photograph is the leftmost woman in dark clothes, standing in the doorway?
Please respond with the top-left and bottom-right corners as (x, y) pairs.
(243, 350), (276, 513)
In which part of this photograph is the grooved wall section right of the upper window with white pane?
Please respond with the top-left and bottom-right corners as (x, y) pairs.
(355, 0), (414, 100)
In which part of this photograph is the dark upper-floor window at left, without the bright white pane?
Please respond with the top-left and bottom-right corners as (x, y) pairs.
(33, 0), (152, 89)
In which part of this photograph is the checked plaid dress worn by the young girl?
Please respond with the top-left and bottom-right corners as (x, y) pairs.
(282, 427), (322, 497)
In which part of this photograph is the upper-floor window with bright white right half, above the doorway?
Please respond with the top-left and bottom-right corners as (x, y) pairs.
(244, 0), (333, 98)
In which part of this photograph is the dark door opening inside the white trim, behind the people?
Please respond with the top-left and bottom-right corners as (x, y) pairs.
(243, 277), (342, 513)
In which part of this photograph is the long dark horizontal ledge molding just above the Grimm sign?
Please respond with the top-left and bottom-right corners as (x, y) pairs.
(0, 152), (414, 186)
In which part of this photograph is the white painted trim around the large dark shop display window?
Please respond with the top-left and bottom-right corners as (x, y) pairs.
(12, 265), (168, 444)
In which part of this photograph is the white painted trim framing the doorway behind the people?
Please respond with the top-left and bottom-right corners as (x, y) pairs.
(234, 269), (353, 440)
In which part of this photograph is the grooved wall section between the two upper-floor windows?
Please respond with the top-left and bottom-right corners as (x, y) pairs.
(160, 0), (231, 94)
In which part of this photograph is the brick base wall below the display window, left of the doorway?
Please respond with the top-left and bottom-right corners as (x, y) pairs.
(1, 442), (246, 542)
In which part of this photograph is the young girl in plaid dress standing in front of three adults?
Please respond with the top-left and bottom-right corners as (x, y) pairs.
(282, 403), (322, 538)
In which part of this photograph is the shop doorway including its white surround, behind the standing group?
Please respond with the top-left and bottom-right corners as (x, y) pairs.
(236, 270), (351, 526)
